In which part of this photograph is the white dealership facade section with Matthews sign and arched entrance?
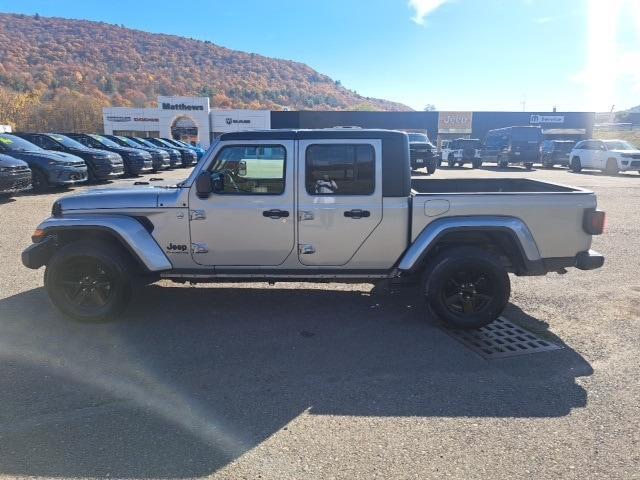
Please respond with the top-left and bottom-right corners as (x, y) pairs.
(102, 96), (271, 148)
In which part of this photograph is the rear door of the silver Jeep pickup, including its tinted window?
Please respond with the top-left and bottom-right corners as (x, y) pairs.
(298, 139), (382, 266)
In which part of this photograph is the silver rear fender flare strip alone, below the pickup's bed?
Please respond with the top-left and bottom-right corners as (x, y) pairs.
(397, 216), (541, 272)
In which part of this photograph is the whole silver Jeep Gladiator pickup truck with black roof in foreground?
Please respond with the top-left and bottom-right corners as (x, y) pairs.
(22, 129), (604, 328)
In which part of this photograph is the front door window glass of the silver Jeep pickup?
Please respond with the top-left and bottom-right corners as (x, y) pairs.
(211, 145), (286, 195)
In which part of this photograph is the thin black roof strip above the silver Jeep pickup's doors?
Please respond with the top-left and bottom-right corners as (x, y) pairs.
(220, 128), (407, 141)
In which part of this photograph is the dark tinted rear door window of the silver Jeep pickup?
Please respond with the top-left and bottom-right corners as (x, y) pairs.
(305, 144), (375, 196)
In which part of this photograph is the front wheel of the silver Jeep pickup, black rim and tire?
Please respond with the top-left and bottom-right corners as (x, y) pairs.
(44, 241), (135, 322)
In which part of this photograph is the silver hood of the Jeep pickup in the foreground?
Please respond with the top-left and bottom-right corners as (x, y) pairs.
(56, 185), (181, 212)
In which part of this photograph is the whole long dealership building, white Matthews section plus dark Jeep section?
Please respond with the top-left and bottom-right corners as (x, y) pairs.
(103, 96), (595, 148)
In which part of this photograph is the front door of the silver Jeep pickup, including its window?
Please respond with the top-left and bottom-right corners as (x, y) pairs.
(189, 140), (295, 266)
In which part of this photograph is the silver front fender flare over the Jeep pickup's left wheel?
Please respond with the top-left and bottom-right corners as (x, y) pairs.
(29, 214), (173, 272)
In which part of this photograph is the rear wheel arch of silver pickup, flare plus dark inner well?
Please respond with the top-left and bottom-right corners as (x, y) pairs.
(397, 217), (544, 275)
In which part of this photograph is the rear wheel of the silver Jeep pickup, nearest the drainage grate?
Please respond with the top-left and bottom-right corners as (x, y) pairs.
(423, 247), (511, 329)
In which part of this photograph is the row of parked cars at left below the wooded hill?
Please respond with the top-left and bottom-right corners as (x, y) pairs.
(0, 132), (199, 196)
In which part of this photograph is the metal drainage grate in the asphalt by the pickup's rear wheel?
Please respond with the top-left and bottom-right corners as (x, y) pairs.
(448, 317), (562, 358)
